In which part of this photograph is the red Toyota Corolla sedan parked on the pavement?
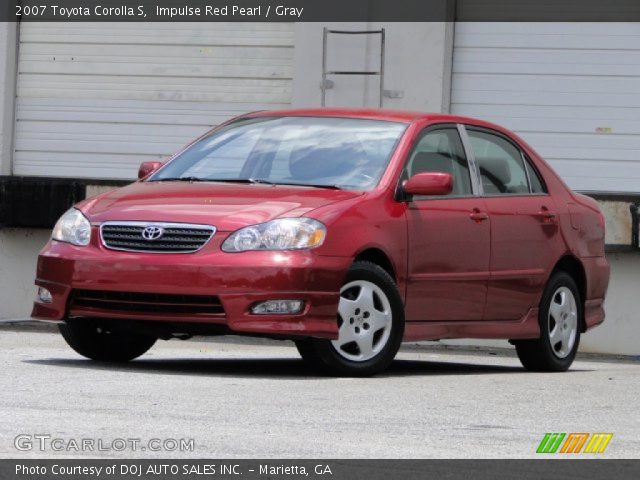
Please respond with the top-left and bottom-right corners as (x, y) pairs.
(33, 110), (609, 375)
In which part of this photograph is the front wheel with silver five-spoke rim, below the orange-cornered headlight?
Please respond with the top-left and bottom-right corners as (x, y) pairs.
(296, 262), (404, 376)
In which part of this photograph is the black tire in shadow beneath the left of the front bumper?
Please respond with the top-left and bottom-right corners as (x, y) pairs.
(59, 320), (157, 362)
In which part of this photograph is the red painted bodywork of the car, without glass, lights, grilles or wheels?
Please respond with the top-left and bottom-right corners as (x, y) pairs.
(33, 109), (609, 340)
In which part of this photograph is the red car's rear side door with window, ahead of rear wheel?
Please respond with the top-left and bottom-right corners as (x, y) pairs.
(466, 126), (561, 320)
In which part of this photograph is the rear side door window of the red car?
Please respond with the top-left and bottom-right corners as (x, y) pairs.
(467, 129), (530, 195)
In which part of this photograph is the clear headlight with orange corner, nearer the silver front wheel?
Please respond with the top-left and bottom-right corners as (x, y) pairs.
(222, 218), (327, 253)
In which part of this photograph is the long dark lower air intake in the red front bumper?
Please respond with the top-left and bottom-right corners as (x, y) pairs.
(69, 290), (224, 315)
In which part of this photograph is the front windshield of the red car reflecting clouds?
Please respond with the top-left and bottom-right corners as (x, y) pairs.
(149, 117), (406, 190)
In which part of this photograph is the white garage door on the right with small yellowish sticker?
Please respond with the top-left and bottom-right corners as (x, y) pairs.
(451, 23), (640, 193)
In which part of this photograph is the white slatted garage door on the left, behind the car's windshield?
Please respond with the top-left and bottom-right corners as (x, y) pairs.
(14, 22), (293, 179)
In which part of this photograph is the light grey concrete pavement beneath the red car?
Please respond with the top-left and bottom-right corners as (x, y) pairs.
(0, 330), (640, 458)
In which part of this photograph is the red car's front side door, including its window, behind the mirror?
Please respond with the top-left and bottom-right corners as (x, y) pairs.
(403, 126), (491, 321)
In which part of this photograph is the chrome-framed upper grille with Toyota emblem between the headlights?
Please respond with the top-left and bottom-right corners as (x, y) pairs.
(100, 222), (216, 253)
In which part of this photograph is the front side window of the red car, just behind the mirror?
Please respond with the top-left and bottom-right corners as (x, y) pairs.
(403, 128), (473, 197)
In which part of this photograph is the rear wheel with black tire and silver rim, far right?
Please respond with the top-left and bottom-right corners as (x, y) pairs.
(514, 271), (583, 372)
